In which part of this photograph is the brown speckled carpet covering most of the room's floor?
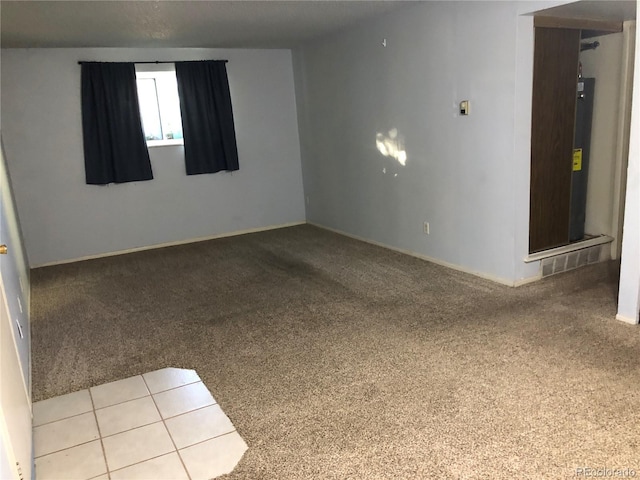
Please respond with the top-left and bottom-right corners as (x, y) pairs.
(32, 226), (640, 479)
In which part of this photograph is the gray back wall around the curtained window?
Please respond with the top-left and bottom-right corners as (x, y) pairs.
(1, 49), (305, 266)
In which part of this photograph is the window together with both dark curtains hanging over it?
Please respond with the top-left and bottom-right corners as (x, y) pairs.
(78, 60), (240, 185)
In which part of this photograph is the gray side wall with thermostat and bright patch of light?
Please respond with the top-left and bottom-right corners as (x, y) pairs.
(294, 2), (548, 284)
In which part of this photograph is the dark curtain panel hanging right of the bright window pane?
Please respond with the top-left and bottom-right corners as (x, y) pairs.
(175, 60), (239, 175)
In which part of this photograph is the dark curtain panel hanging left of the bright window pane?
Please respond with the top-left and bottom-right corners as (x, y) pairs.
(82, 62), (153, 185)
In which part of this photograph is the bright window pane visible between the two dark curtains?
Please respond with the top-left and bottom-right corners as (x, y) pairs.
(136, 64), (183, 147)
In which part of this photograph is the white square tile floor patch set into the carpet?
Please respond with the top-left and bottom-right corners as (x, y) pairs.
(33, 368), (247, 480)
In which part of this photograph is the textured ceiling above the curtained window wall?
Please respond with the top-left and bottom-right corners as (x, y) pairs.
(0, 0), (407, 48)
